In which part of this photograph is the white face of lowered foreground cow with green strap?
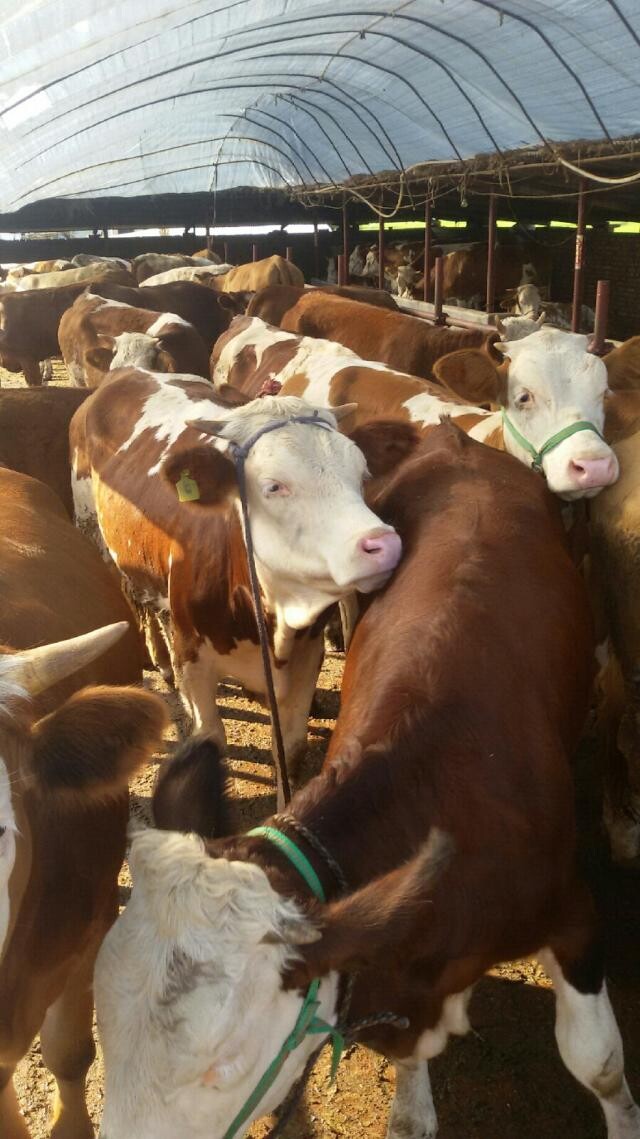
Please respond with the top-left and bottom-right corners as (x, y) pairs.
(95, 830), (337, 1139)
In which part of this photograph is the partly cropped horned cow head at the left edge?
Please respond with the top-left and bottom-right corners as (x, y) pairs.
(0, 622), (166, 956)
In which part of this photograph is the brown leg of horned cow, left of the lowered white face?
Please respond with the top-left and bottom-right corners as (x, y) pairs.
(40, 947), (97, 1139)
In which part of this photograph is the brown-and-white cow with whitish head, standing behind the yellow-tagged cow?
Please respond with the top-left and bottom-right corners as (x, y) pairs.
(58, 292), (208, 387)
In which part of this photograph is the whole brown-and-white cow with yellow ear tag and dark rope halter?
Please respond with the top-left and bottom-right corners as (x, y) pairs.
(69, 382), (401, 792)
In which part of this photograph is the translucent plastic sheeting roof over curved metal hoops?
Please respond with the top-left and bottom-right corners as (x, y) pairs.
(0, 0), (640, 211)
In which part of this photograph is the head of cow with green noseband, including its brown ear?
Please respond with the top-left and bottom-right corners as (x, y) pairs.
(434, 326), (618, 500)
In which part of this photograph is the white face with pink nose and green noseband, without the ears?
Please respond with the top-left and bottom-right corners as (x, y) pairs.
(501, 327), (618, 499)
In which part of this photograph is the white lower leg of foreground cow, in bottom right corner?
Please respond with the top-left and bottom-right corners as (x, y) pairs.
(539, 927), (640, 1139)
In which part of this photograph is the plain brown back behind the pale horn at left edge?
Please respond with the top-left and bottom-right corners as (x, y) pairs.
(0, 468), (142, 712)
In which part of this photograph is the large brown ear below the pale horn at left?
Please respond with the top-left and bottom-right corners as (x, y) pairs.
(31, 688), (169, 804)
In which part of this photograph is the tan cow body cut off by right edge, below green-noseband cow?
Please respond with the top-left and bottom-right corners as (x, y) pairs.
(590, 387), (640, 863)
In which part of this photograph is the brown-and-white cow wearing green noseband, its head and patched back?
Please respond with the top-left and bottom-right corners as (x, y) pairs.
(211, 321), (618, 500)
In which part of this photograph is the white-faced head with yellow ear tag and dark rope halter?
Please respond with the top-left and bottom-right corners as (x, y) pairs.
(164, 396), (401, 629)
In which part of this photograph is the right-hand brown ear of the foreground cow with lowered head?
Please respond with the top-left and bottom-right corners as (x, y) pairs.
(286, 828), (453, 983)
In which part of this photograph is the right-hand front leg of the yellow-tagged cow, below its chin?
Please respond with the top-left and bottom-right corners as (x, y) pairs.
(271, 634), (325, 782)
